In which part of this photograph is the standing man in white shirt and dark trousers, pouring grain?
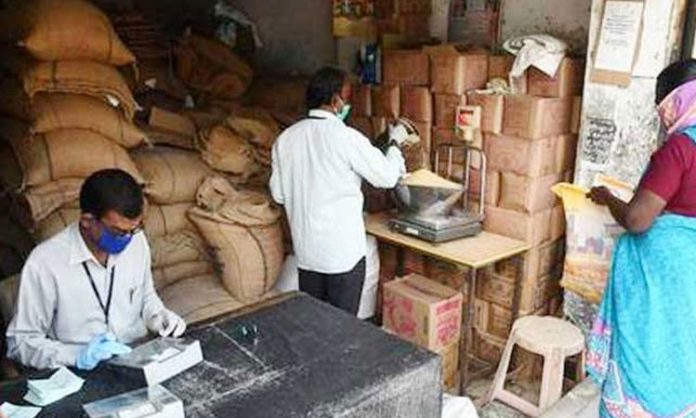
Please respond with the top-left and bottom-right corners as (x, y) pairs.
(270, 68), (408, 314)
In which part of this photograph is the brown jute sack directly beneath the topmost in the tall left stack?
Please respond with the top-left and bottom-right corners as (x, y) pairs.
(24, 61), (138, 120)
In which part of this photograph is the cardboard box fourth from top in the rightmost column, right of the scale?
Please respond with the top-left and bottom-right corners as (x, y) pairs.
(497, 172), (564, 213)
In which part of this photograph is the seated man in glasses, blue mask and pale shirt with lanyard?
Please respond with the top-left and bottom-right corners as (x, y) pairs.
(7, 170), (186, 369)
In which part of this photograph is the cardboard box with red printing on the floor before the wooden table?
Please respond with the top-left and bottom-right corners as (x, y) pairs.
(383, 274), (463, 350)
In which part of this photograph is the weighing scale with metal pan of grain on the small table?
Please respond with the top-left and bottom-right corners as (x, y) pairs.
(390, 144), (486, 243)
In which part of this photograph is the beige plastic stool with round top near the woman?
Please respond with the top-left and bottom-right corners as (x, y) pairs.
(484, 316), (585, 417)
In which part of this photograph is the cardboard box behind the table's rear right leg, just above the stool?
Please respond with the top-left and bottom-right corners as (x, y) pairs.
(476, 266), (562, 312)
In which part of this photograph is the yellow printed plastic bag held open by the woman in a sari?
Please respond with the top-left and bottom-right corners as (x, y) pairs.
(551, 176), (633, 303)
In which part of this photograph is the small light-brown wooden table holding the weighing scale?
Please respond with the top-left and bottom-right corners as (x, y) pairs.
(365, 213), (531, 394)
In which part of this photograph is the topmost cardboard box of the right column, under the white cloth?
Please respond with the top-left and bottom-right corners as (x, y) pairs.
(529, 58), (585, 97)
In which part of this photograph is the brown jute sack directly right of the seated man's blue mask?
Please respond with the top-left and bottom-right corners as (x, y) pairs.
(149, 230), (210, 268)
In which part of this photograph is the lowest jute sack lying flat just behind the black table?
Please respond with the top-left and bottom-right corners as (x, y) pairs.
(158, 274), (243, 324)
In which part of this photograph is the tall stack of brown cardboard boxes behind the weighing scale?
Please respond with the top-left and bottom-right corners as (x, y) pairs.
(372, 46), (584, 372)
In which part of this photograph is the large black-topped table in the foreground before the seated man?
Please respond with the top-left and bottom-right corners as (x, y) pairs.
(0, 293), (442, 418)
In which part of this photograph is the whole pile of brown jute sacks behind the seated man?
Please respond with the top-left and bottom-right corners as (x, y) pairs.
(0, 0), (284, 321)
